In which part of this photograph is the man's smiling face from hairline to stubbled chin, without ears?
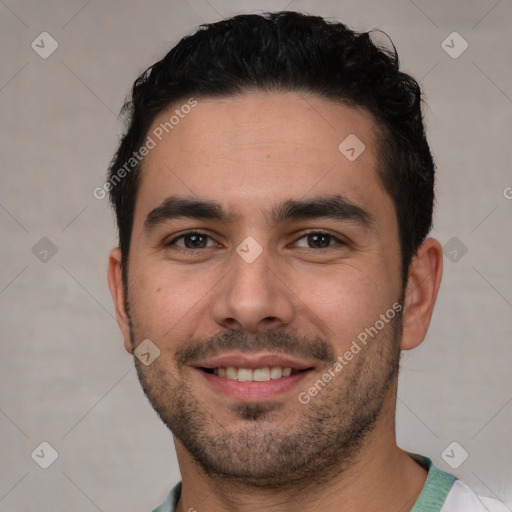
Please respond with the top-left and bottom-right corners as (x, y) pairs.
(118, 93), (402, 486)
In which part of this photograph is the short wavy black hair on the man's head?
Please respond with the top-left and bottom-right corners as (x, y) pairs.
(107, 11), (435, 286)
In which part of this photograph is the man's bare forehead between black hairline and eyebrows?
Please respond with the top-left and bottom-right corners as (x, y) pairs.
(136, 92), (384, 222)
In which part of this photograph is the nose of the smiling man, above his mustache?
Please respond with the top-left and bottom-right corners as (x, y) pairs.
(212, 247), (294, 333)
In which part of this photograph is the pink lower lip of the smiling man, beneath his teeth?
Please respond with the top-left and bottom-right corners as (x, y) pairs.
(197, 370), (309, 402)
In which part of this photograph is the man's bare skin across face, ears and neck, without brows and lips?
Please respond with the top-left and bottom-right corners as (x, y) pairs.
(108, 92), (442, 512)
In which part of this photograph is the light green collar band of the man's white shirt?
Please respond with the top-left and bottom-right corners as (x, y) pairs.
(153, 454), (460, 512)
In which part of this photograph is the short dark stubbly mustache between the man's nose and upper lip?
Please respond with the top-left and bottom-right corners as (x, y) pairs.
(174, 330), (335, 366)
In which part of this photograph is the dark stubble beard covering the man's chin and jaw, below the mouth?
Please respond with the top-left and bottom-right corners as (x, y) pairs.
(130, 308), (402, 489)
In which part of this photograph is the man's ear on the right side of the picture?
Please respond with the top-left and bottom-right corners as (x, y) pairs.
(402, 238), (443, 350)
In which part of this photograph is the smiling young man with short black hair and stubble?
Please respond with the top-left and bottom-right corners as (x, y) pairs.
(105, 12), (504, 512)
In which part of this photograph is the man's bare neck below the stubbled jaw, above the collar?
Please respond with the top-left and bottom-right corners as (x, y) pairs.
(175, 392), (427, 512)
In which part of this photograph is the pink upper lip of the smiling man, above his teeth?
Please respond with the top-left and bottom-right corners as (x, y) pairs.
(194, 352), (313, 370)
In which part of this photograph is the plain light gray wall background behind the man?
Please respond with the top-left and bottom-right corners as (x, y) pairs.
(0, 0), (512, 512)
